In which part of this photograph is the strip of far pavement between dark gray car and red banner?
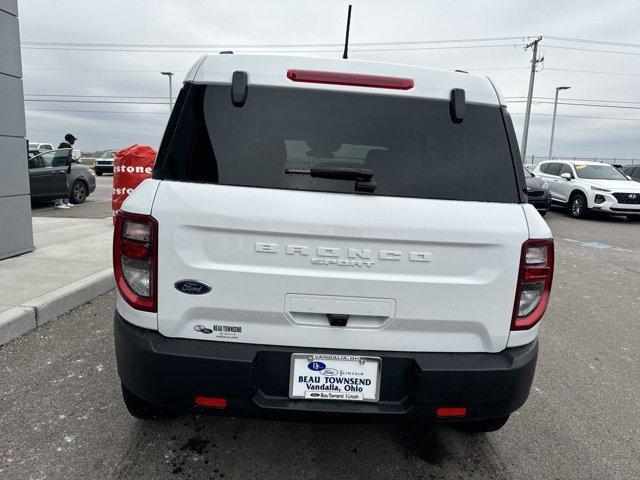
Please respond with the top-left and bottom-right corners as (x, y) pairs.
(31, 174), (113, 218)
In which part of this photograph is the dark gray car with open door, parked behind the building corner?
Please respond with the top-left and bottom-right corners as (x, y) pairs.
(29, 148), (96, 203)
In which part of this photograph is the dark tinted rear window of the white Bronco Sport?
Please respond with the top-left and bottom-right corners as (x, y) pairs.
(154, 85), (520, 202)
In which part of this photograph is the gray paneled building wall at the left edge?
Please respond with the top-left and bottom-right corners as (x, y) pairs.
(0, 0), (34, 259)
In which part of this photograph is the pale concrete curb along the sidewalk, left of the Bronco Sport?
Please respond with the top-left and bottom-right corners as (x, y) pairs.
(0, 268), (115, 345)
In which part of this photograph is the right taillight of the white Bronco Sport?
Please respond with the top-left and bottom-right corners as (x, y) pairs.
(511, 238), (553, 330)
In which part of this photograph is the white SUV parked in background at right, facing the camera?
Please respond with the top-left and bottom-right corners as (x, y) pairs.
(535, 160), (640, 221)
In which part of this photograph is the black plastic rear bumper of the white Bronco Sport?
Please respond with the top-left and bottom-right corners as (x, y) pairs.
(115, 312), (538, 421)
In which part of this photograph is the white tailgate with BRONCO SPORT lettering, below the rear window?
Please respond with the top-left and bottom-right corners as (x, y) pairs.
(152, 181), (528, 352)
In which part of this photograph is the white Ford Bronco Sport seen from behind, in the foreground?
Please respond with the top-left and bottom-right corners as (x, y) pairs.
(114, 54), (553, 431)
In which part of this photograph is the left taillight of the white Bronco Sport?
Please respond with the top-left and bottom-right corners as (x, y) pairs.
(113, 211), (158, 312)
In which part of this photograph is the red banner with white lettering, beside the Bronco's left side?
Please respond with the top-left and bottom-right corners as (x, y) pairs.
(111, 144), (157, 216)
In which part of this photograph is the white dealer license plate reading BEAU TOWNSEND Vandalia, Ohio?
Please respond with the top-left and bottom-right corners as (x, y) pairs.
(289, 353), (382, 402)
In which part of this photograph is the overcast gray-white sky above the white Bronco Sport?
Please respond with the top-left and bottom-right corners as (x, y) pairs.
(18, 0), (640, 158)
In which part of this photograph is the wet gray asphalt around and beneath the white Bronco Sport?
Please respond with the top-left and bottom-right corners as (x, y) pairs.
(0, 212), (640, 480)
